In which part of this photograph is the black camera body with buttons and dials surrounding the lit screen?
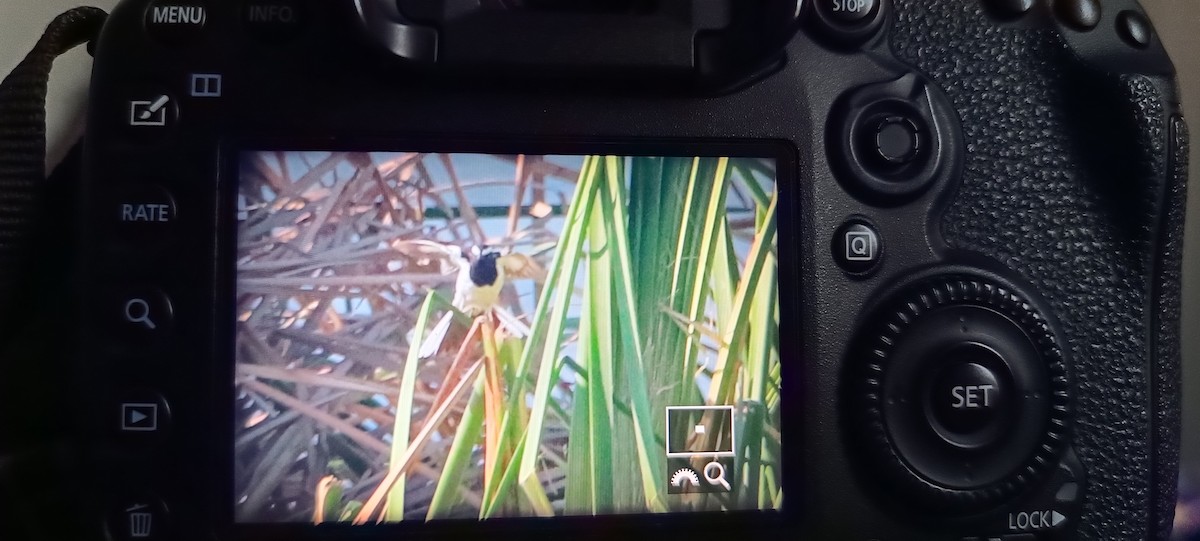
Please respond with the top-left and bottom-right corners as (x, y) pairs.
(78, 0), (1187, 541)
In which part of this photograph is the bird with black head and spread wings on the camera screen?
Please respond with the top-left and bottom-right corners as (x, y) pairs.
(408, 240), (546, 357)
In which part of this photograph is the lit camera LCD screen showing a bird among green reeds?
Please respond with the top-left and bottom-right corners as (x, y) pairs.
(232, 150), (784, 524)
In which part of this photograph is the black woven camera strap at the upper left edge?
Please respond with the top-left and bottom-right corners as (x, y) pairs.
(0, 7), (108, 331)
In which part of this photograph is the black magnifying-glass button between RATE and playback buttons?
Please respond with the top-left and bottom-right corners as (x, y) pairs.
(104, 287), (174, 348)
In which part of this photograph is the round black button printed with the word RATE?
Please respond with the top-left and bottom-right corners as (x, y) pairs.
(106, 185), (179, 241)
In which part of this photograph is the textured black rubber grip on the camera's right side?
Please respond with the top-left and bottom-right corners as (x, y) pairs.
(892, 0), (1182, 540)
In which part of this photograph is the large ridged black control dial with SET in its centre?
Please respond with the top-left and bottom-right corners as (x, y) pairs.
(842, 275), (1069, 515)
